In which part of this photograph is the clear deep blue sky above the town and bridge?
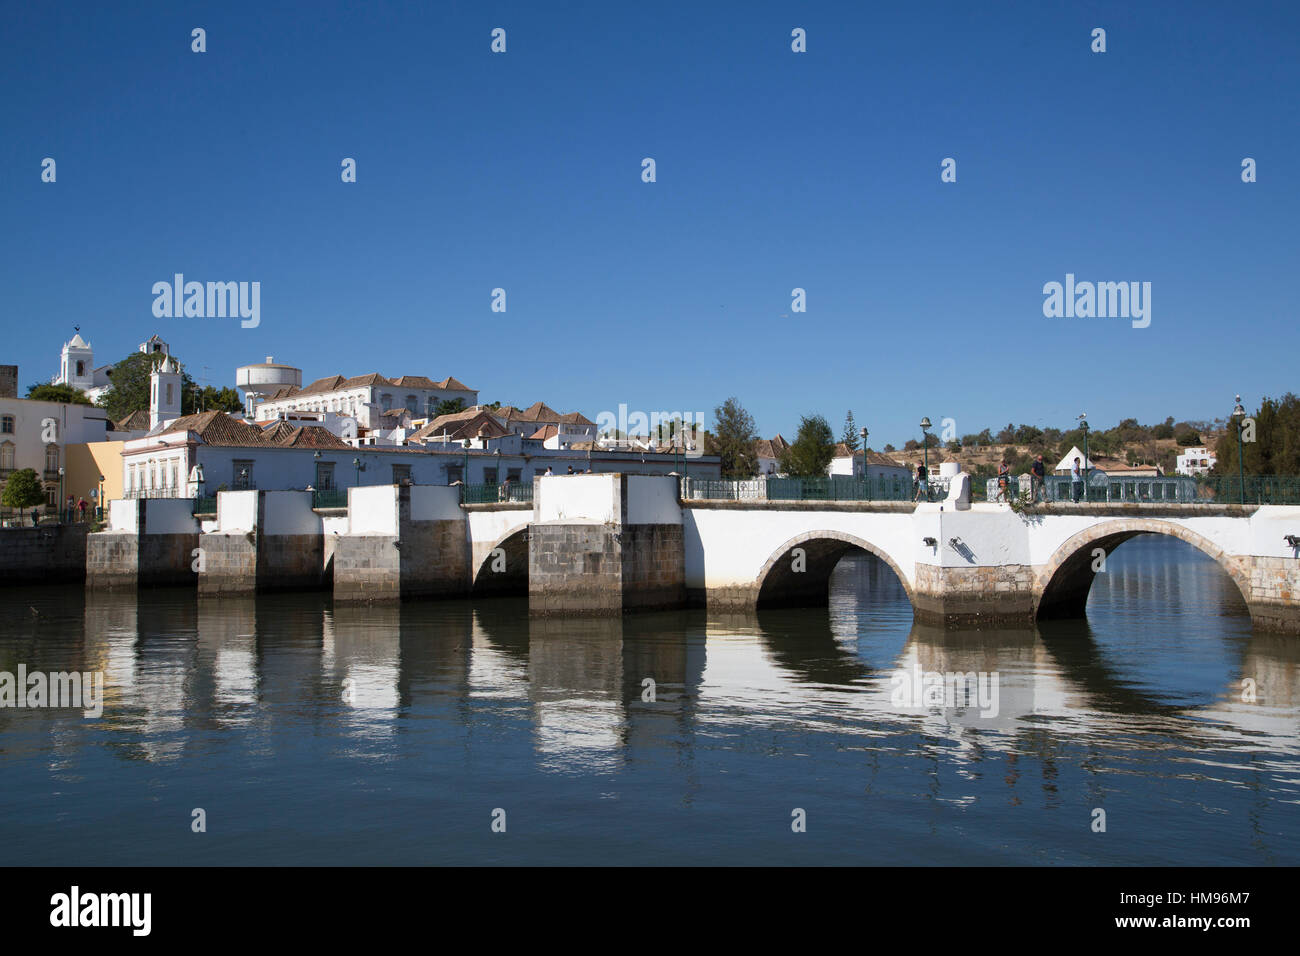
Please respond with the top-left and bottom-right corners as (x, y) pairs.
(0, 1), (1300, 447)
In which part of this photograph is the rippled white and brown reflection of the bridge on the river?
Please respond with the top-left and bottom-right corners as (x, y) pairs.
(0, 592), (1284, 771)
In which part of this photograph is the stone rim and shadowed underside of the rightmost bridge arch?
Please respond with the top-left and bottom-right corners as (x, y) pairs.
(1034, 518), (1251, 620)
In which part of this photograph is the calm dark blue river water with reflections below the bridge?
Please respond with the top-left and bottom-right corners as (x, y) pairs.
(0, 536), (1300, 865)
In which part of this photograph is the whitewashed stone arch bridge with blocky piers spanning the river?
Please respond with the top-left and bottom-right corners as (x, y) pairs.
(87, 475), (1300, 633)
